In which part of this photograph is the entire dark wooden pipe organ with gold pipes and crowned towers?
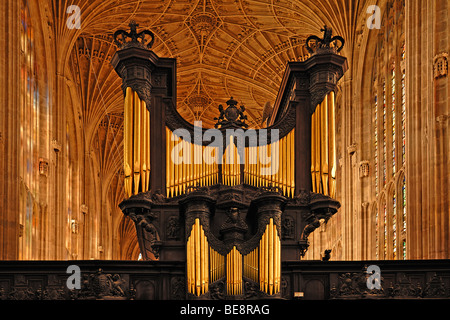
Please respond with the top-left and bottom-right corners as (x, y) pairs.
(111, 23), (347, 299)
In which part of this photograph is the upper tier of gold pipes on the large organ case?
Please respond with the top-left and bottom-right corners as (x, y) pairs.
(142, 97), (336, 198)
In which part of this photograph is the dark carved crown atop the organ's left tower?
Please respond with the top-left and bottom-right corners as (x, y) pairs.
(113, 20), (155, 49)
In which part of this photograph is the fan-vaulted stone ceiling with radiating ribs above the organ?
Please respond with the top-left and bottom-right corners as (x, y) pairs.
(66, 0), (370, 127)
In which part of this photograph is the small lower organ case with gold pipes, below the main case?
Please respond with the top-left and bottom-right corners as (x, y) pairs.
(183, 190), (286, 296)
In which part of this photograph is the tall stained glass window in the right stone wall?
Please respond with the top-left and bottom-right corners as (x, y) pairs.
(369, 0), (407, 259)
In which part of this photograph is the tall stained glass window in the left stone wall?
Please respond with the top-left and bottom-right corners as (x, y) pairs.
(17, 0), (50, 259)
